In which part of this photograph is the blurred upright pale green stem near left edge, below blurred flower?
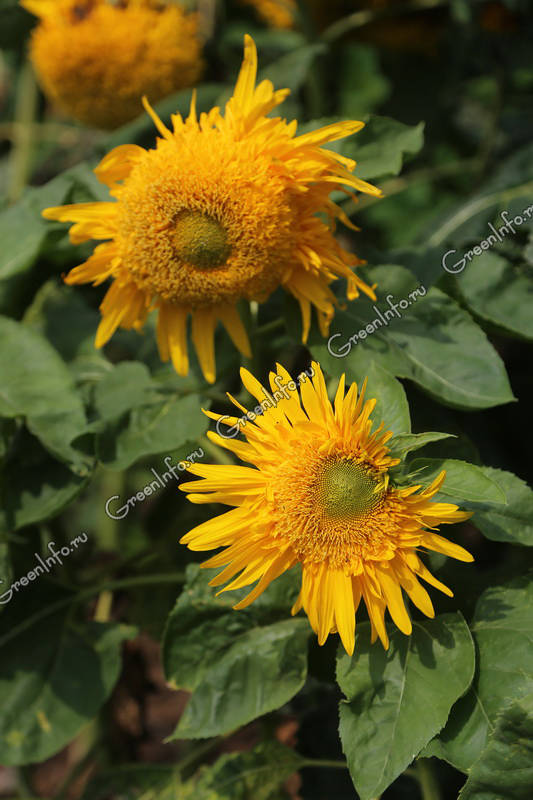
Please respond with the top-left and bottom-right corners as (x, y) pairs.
(7, 61), (39, 203)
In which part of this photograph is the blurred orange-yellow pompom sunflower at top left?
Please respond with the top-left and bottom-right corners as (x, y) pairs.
(21, 0), (203, 128)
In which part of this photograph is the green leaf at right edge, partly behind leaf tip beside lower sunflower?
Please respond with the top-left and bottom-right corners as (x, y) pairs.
(468, 467), (533, 547)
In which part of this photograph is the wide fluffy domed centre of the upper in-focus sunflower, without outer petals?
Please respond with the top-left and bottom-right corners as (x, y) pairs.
(115, 128), (301, 308)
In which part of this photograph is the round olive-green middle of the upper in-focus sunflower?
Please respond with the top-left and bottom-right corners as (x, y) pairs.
(172, 211), (231, 269)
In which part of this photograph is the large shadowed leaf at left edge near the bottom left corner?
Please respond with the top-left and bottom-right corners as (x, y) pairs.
(0, 596), (135, 766)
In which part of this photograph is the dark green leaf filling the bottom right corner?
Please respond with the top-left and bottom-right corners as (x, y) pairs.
(459, 694), (533, 800)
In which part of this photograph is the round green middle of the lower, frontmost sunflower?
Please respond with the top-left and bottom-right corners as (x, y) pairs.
(318, 461), (385, 519)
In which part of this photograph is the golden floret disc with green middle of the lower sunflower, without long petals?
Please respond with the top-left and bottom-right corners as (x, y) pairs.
(268, 438), (397, 575)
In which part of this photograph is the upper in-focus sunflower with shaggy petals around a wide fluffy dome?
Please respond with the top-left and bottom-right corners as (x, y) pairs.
(43, 36), (381, 382)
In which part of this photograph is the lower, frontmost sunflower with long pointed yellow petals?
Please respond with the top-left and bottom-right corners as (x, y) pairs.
(180, 363), (472, 655)
